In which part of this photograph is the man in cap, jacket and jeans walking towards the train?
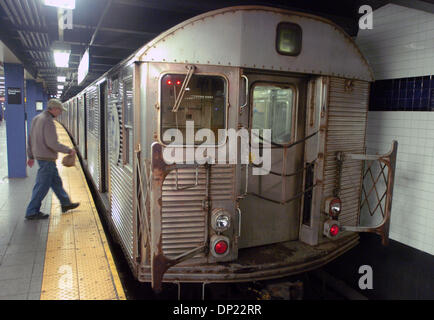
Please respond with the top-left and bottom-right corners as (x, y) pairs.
(26, 99), (80, 220)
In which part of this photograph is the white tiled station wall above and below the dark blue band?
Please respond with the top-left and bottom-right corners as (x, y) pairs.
(356, 4), (434, 254)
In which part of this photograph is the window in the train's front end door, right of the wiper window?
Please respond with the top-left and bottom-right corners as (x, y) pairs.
(252, 83), (295, 144)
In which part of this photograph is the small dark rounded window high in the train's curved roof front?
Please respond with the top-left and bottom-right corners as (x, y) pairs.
(276, 22), (302, 56)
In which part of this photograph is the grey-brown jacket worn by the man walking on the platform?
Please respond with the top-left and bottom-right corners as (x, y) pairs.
(27, 111), (71, 160)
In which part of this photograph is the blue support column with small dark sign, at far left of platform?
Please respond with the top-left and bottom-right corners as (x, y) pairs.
(4, 63), (27, 178)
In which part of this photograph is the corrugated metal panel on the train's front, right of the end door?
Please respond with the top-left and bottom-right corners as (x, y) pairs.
(323, 78), (369, 226)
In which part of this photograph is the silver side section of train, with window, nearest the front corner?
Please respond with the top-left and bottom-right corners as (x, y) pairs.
(107, 66), (137, 263)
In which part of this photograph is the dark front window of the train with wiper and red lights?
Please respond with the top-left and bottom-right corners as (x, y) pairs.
(160, 74), (226, 144)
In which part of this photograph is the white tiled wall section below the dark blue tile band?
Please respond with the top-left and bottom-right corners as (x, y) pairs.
(367, 111), (434, 254)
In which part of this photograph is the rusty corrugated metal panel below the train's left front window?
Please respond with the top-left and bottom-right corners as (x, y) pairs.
(162, 165), (235, 258)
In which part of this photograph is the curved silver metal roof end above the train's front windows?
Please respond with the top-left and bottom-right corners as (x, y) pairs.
(135, 6), (374, 81)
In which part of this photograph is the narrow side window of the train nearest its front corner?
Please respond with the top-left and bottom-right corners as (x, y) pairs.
(123, 76), (134, 168)
